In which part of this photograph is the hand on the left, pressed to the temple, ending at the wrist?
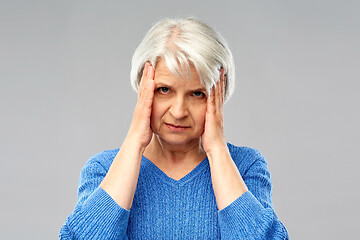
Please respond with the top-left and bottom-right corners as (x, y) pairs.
(126, 62), (155, 149)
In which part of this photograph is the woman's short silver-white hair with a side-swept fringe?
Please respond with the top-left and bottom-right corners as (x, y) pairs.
(130, 17), (235, 102)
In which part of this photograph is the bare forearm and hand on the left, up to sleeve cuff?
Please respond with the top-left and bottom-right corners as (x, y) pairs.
(100, 63), (155, 210)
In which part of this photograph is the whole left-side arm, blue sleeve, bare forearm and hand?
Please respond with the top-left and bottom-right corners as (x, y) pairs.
(60, 63), (155, 239)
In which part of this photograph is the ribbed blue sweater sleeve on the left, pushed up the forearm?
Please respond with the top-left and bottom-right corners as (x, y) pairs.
(59, 155), (130, 239)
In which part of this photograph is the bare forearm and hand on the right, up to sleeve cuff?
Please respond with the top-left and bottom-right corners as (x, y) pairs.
(201, 69), (248, 209)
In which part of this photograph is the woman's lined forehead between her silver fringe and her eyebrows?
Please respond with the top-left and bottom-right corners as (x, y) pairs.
(154, 59), (204, 87)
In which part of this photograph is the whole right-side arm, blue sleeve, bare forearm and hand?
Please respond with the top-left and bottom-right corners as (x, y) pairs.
(201, 69), (288, 239)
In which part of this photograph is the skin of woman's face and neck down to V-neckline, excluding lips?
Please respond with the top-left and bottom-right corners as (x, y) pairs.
(144, 57), (207, 180)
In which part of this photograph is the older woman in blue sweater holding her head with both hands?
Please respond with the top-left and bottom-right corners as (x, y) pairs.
(60, 18), (288, 239)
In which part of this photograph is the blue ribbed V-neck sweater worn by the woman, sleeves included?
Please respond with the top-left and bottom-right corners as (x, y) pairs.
(59, 143), (289, 239)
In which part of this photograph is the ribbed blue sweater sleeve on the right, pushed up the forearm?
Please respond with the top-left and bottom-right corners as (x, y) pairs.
(218, 151), (289, 239)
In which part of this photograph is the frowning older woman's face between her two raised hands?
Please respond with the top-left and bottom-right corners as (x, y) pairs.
(151, 59), (207, 145)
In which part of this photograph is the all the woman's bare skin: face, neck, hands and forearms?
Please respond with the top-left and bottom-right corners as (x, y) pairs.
(100, 60), (248, 210)
